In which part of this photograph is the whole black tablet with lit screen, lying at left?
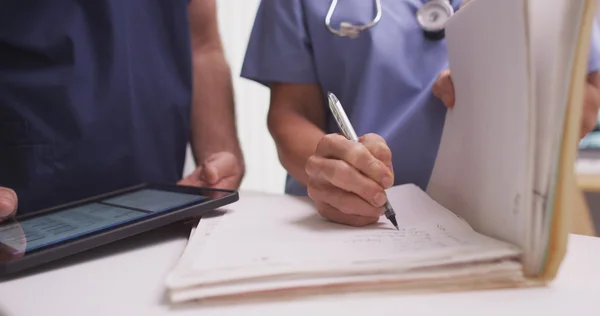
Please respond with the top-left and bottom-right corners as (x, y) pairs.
(0, 184), (238, 276)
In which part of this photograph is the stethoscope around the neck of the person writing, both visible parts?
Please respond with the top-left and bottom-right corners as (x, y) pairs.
(325, 0), (454, 40)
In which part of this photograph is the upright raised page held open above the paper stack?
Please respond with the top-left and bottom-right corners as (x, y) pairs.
(427, 0), (535, 249)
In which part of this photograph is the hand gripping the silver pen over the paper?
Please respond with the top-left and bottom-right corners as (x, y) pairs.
(305, 134), (394, 226)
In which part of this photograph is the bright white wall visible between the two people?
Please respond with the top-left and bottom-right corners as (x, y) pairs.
(184, 0), (287, 193)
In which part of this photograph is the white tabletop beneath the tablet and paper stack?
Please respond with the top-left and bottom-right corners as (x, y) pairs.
(0, 201), (600, 316)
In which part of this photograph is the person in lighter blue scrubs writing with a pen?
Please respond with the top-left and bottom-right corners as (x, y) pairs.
(241, 0), (600, 226)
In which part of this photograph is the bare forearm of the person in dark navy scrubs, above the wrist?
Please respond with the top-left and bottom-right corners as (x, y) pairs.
(191, 49), (243, 165)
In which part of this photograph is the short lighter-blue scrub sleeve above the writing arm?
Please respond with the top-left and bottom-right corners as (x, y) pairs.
(241, 0), (318, 85)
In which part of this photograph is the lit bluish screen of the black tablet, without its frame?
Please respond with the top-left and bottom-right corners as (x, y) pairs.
(0, 189), (206, 253)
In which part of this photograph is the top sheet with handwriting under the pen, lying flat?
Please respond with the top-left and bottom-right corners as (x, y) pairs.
(194, 186), (517, 282)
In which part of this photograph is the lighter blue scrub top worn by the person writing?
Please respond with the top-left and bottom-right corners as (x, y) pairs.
(241, 0), (600, 195)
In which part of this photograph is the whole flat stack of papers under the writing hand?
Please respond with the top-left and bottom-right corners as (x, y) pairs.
(167, 185), (523, 302)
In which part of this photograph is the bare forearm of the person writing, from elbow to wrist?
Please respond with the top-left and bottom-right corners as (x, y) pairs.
(269, 112), (325, 186)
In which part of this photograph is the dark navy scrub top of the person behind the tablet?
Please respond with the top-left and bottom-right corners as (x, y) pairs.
(0, 0), (192, 213)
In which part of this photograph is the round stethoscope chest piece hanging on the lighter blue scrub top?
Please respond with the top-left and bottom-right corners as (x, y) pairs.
(417, 0), (454, 40)
